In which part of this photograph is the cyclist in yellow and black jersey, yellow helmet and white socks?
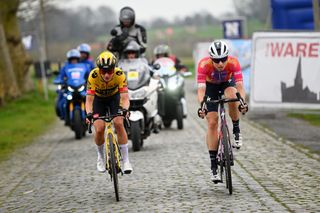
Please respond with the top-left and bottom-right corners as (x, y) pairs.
(86, 51), (132, 174)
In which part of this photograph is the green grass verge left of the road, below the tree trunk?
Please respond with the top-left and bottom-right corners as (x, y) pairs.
(0, 92), (55, 161)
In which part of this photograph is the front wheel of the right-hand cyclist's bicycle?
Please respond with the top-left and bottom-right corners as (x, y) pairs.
(222, 125), (232, 195)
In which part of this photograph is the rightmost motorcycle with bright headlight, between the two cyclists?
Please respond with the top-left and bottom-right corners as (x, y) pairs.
(154, 57), (191, 129)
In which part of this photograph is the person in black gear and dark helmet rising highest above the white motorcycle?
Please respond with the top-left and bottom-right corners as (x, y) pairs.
(107, 7), (147, 59)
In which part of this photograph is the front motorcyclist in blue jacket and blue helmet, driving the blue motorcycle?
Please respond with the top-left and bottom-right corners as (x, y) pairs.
(53, 49), (90, 125)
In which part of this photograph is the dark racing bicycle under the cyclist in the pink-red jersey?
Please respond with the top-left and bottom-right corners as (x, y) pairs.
(201, 92), (246, 195)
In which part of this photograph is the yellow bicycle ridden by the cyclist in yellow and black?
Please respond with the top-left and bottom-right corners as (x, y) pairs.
(88, 111), (124, 201)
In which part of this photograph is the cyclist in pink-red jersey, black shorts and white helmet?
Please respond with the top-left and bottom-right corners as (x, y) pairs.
(197, 40), (248, 182)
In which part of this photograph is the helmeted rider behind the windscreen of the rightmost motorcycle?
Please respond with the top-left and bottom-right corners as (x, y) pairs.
(151, 44), (188, 72)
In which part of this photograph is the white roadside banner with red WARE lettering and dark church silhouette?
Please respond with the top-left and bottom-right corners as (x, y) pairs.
(250, 32), (320, 109)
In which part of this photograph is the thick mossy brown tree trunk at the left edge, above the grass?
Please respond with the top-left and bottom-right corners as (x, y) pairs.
(0, 0), (31, 104)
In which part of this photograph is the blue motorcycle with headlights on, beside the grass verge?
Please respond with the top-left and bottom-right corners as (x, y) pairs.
(54, 69), (87, 139)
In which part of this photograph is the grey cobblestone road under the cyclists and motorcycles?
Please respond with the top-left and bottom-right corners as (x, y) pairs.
(0, 80), (320, 212)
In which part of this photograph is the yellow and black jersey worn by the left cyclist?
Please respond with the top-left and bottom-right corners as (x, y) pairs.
(87, 67), (128, 97)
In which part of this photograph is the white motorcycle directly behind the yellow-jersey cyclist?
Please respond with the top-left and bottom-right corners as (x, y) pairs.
(119, 58), (161, 151)
